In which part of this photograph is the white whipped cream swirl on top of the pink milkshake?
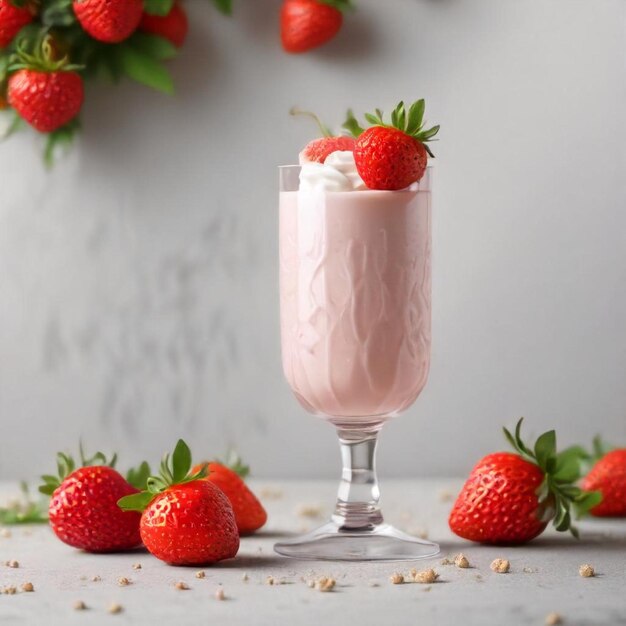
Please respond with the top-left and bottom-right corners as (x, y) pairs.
(300, 150), (366, 191)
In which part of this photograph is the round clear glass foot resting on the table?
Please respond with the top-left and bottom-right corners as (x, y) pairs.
(274, 522), (439, 561)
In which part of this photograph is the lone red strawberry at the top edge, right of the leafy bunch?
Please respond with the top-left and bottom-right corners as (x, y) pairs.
(280, 0), (351, 53)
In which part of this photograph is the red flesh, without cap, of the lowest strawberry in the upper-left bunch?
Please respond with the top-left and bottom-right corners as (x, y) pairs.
(8, 69), (84, 133)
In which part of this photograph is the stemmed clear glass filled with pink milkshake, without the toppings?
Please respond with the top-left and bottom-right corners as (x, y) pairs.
(275, 166), (439, 560)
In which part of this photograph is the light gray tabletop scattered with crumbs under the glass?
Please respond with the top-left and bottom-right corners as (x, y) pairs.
(0, 480), (626, 626)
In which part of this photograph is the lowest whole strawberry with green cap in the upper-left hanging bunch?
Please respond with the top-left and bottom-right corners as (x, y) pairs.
(8, 37), (84, 133)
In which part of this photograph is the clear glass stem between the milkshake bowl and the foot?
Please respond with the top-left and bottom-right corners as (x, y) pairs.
(332, 424), (383, 530)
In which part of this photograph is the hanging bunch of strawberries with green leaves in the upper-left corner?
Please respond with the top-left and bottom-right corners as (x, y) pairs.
(0, 0), (231, 161)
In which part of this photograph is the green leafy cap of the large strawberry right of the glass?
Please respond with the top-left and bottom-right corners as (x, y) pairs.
(503, 418), (602, 538)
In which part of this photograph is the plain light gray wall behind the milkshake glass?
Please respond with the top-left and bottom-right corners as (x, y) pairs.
(0, 0), (626, 478)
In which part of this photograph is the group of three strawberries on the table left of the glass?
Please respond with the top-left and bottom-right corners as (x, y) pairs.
(39, 440), (267, 565)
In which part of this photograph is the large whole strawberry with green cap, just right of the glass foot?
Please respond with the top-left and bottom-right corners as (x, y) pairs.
(448, 420), (599, 544)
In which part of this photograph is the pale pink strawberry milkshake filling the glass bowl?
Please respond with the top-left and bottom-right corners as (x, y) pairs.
(280, 184), (431, 418)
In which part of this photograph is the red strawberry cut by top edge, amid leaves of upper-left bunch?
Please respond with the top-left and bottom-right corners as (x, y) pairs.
(73, 0), (143, 43)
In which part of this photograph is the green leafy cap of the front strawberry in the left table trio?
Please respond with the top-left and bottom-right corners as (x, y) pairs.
(117, 439), (208, 512)
